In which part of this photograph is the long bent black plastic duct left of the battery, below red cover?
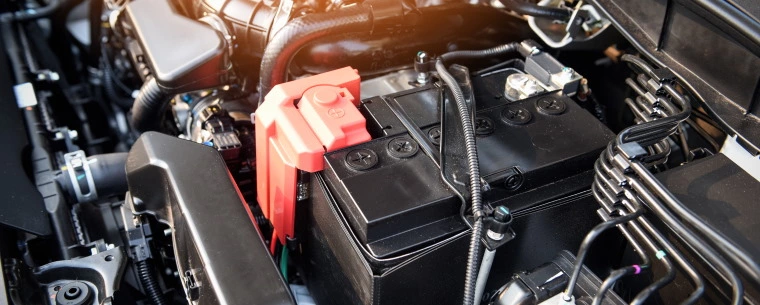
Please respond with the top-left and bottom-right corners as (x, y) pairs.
(127, 132), (295, 305)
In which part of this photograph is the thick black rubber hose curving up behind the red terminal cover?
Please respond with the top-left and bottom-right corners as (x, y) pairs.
(259, 5), (373, 103)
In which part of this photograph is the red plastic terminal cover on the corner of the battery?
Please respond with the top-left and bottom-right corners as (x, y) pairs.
(253, 67), (371, 244)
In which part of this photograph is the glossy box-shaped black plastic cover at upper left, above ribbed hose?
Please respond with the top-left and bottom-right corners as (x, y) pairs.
(125, 0), (229, 91)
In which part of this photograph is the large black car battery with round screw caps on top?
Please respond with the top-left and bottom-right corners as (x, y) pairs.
(304, 60), (614, 304)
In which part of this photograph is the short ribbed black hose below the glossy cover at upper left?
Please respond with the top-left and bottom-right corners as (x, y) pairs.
(132, 78), (171, 133)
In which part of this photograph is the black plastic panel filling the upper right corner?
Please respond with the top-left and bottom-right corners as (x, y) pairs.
(589, 0), (760, 154)
